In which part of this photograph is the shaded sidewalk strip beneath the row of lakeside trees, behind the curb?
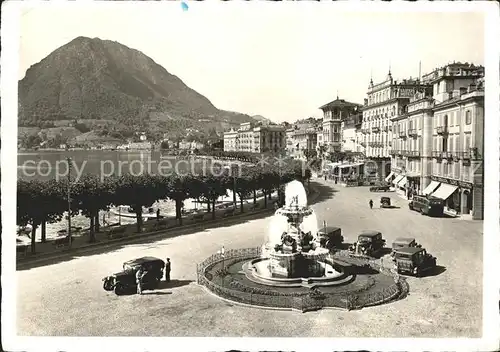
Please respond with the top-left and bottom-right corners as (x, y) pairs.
(16, 187), (319, 266)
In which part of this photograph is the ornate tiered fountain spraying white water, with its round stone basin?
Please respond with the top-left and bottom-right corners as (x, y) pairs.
(243, 181), (346, 286)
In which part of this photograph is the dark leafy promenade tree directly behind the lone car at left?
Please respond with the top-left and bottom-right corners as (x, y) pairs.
(112, 174), (162, 232)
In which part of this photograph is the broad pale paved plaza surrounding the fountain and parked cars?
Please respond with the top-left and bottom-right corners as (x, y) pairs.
(17, 180), (483, 337)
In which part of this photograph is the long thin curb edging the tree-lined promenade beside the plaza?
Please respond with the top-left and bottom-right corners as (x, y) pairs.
(16, 183), (319, 269)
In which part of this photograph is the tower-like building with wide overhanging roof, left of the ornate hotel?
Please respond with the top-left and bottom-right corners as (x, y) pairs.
(320, 97), (361, 153)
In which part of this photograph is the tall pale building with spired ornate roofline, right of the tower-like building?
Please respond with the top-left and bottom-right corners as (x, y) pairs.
(361, 71), (422, 179)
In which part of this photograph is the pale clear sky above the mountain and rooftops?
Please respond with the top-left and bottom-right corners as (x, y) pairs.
(19, 1), (484, 122)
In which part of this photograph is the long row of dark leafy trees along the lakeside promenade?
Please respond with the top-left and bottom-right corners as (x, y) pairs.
(17, 161), (311, 253)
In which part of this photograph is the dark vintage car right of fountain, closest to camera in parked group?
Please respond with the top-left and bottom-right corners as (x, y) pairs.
(393, 247), (436, 277)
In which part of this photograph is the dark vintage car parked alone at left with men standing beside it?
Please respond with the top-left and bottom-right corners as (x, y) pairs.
(102, 257), (165, 295)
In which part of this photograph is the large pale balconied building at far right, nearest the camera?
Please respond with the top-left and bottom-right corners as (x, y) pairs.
(391, 63), (484, 219)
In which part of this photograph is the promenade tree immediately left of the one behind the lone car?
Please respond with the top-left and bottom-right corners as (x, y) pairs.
(73, 174), (115, 242)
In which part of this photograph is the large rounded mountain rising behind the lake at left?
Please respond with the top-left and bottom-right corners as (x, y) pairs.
(18, 37), (253, 143)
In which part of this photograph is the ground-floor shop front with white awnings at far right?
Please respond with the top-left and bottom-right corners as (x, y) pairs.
(423, 176), (476, 218)
